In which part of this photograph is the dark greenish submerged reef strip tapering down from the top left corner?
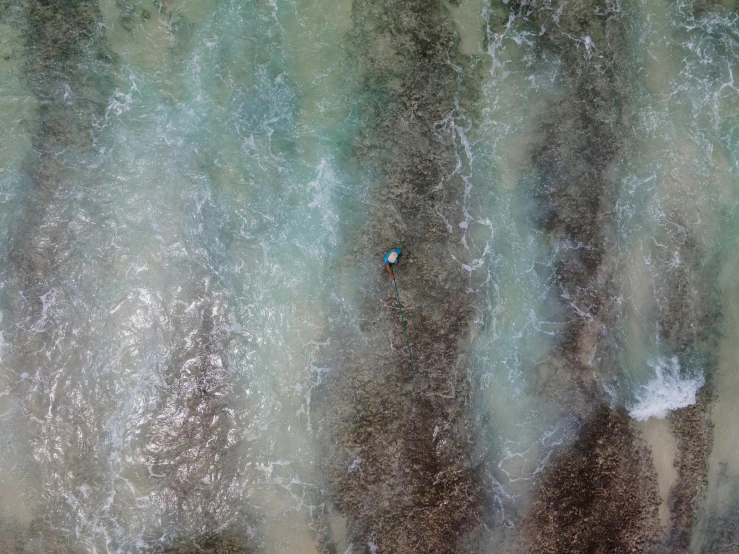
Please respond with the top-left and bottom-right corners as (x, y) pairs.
(9, 0), (115, 280)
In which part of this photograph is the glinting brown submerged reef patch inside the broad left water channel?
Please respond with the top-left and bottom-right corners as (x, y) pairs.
(140, 287), (243, 536)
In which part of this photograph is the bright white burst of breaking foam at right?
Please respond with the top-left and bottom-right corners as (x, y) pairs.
(629, 356), (706, 421)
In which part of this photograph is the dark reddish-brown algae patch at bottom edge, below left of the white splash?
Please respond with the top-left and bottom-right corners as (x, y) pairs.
(519, 406), (660, 554)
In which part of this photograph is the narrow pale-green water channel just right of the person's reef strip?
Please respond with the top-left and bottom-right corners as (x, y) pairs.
(460, 5), (571, 552)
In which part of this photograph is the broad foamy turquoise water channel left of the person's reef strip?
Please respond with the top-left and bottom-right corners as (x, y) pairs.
(42, 3), (362, 552)
